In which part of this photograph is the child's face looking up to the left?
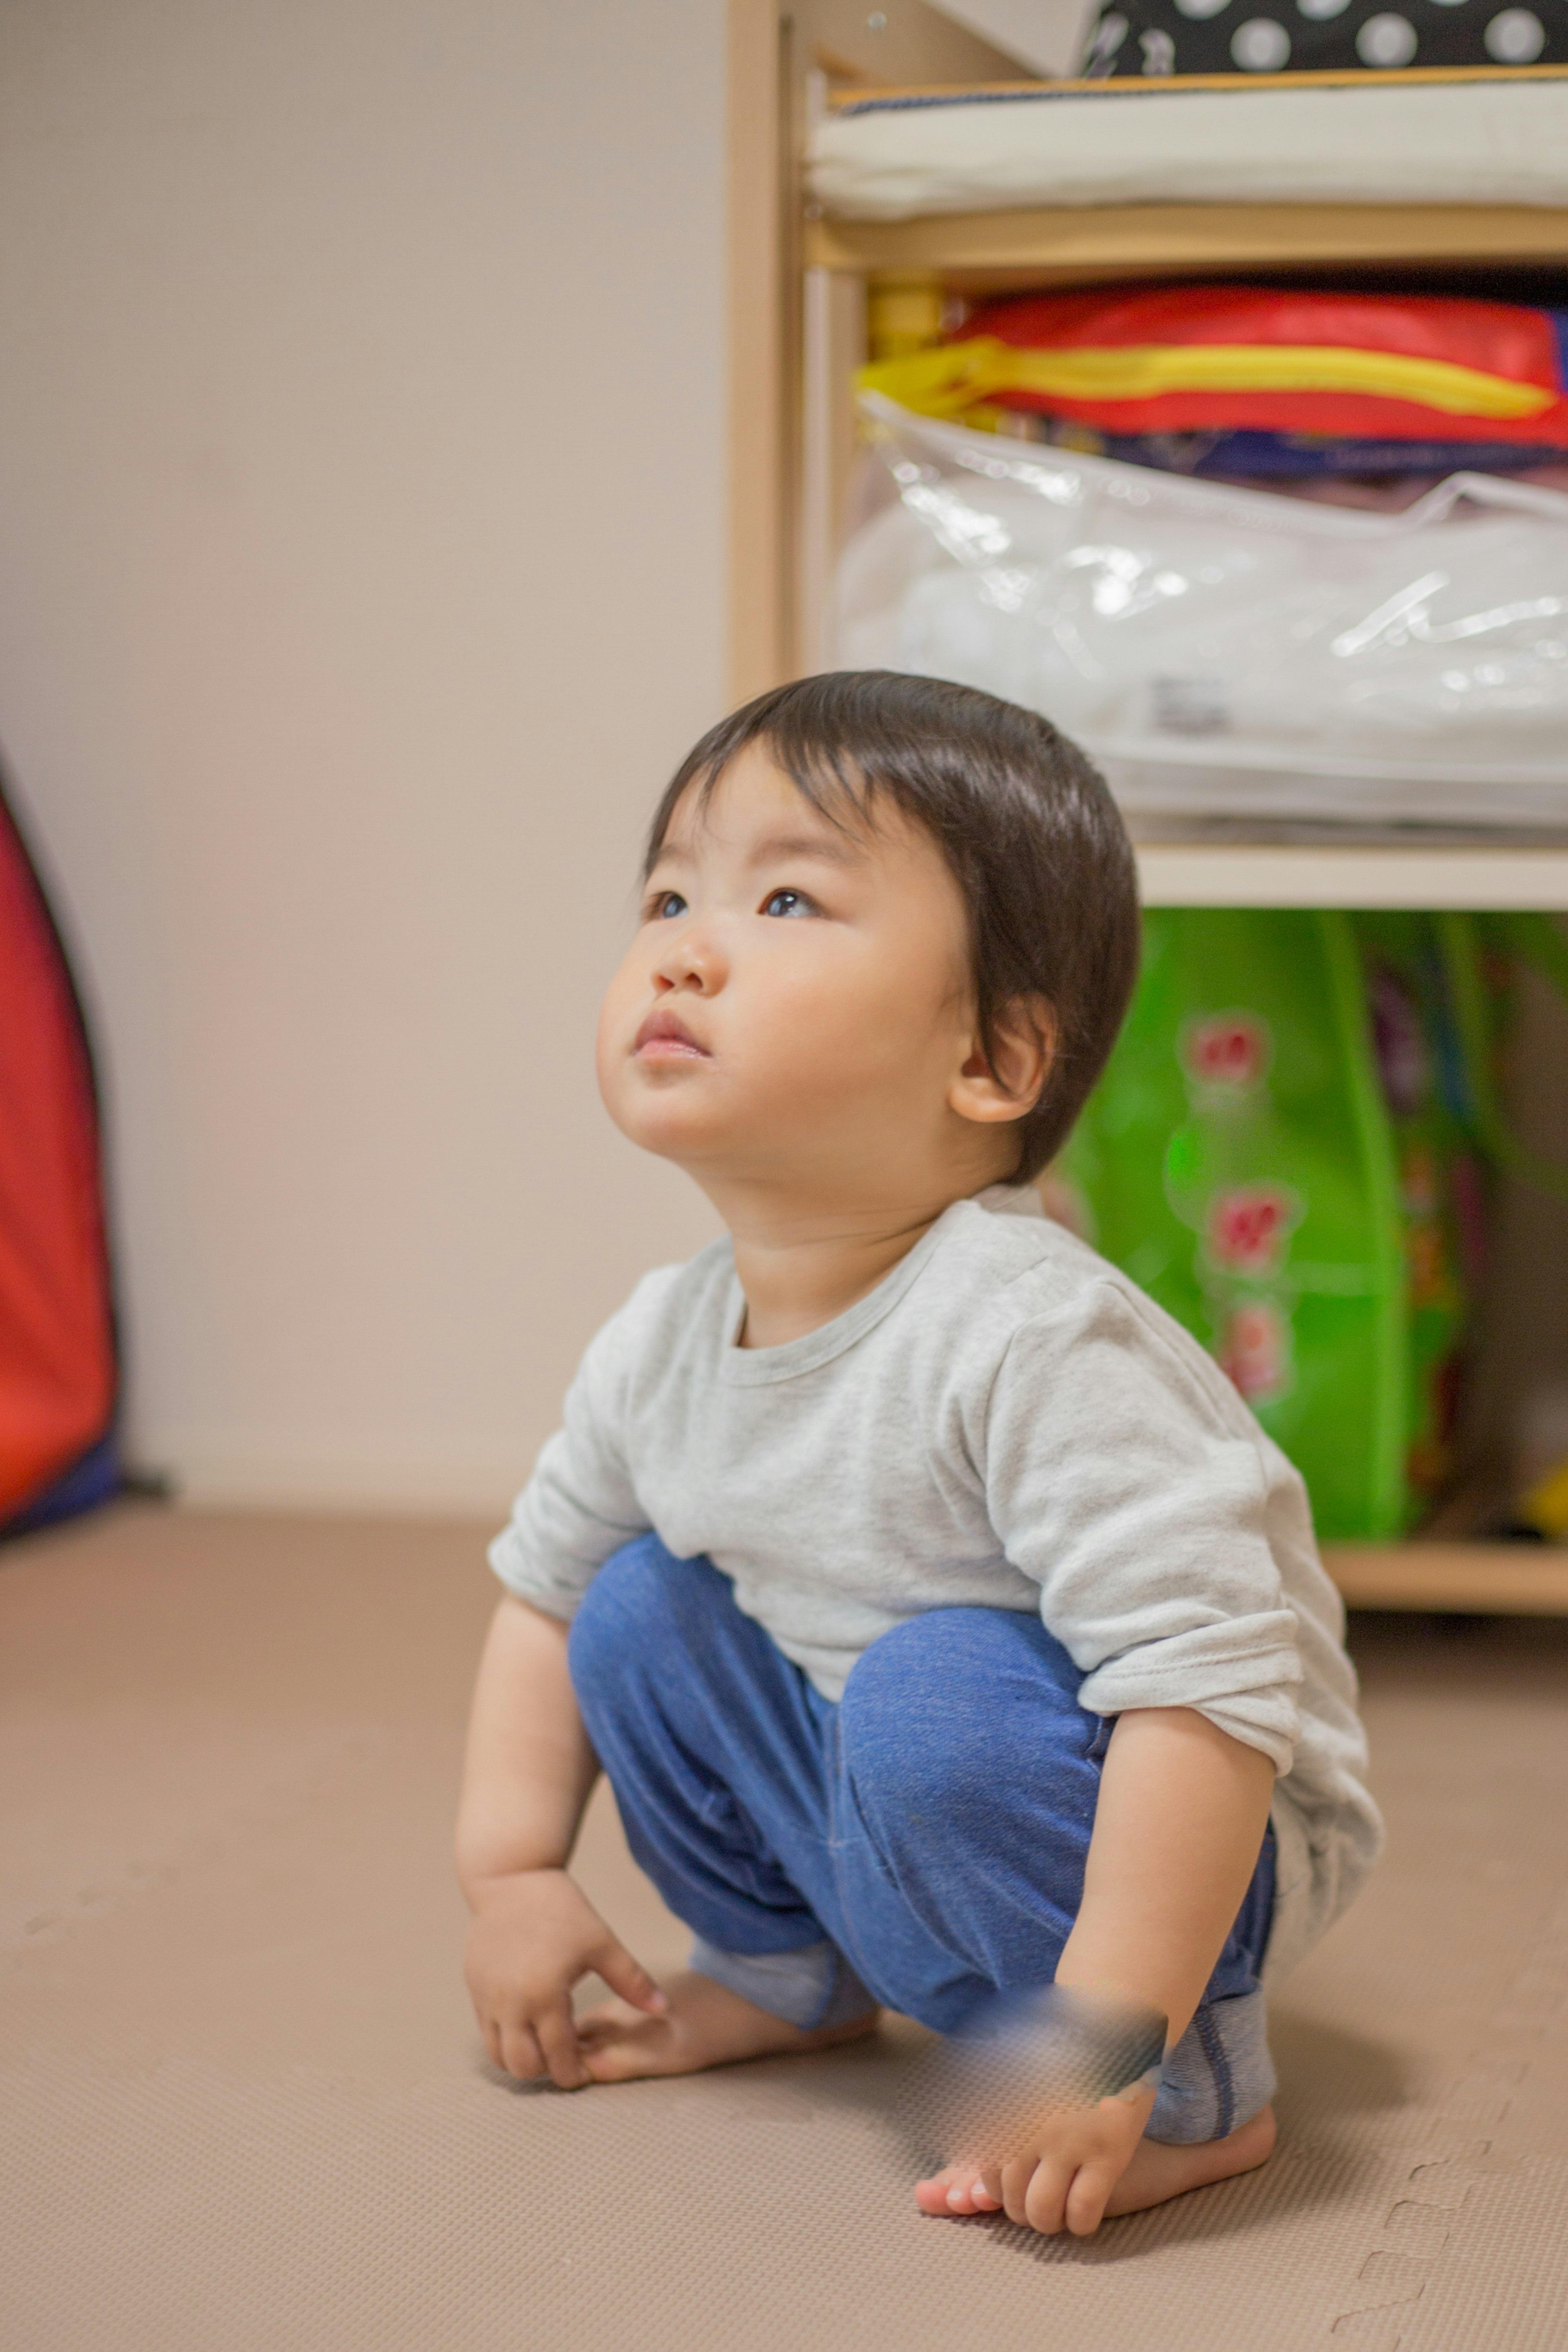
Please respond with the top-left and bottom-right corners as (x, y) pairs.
(599, 746), (1018, 1207)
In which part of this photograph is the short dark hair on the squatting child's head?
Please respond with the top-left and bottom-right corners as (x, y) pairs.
(644, 670), (1138, 1183)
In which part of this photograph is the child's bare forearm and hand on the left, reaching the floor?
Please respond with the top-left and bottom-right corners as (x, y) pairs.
(456, 1599), (665, 2091)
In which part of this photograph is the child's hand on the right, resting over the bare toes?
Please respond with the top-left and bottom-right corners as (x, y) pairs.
(915, 2086), (1154, 2237)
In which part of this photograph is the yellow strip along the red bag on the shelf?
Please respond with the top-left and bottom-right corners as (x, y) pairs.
(856, 334), (1559, 419)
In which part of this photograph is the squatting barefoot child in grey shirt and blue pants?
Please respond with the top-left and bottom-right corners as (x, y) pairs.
(459, 673), (1380, 2234)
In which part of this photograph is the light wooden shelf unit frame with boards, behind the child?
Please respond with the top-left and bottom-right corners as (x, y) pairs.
(729, 0), (1568, 1616)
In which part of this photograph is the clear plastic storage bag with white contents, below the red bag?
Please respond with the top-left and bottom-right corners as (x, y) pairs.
(832, 395), (1568, 828)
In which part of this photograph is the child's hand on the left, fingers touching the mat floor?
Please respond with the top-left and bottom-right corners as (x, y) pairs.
(463, 1870), (665, 2091)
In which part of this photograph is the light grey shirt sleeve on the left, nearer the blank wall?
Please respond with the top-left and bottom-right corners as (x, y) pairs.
(489, 1296), (649, 1618)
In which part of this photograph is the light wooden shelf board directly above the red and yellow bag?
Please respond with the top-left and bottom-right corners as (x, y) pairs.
(804, 205), (1568, 289)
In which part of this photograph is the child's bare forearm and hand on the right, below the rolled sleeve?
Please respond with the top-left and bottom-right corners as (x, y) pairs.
(959, 1708), (1274, 2237)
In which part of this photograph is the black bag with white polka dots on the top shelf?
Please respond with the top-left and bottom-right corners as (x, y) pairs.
(1079, 0), (1568, 82)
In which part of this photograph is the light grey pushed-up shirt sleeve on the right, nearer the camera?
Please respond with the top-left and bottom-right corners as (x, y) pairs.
(982, 1282), (1302, 1773)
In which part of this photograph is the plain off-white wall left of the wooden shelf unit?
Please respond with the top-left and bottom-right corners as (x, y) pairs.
(0, 0), (724, 1508)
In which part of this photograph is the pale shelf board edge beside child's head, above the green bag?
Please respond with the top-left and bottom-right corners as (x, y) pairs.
(1138, 842), (1568, 913)
